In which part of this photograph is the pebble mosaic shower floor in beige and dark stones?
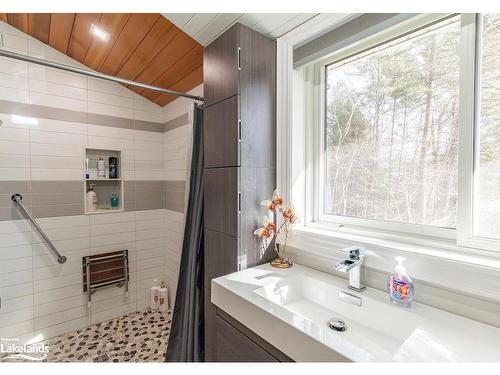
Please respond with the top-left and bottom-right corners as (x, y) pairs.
(0, 310), (172, 362)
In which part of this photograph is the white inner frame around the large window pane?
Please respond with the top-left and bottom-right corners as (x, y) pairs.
(301, 13), (500, 252)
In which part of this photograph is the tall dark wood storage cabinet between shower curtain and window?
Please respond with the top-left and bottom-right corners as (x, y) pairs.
(203, 24), (276, 361)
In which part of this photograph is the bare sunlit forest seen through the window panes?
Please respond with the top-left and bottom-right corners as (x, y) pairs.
(308, 14), (500, 250)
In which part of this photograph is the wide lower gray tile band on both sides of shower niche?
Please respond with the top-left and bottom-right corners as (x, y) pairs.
(0, 181), (186, 221)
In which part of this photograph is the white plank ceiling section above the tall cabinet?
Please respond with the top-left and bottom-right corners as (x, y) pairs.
(162, 13), (317, 46)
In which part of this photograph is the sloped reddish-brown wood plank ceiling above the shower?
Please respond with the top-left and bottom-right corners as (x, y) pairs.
(0, 13), (203, 106)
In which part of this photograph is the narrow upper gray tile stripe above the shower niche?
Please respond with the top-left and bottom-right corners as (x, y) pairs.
(0, 100), (182, 133)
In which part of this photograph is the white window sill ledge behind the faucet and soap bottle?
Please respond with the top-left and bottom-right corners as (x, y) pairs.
(289, 225), (500, 303)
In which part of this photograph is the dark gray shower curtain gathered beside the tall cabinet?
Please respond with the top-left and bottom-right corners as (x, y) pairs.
(165, 105), (204, 362)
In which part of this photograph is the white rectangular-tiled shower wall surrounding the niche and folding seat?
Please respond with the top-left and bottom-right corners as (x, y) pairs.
(0, 22), (198, 340)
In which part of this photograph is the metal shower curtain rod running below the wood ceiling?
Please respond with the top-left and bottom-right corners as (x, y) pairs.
(0, 49), (204, 102)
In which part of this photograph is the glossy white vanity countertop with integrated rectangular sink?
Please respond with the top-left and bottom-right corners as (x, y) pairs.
(212, 264), (500, 362)
